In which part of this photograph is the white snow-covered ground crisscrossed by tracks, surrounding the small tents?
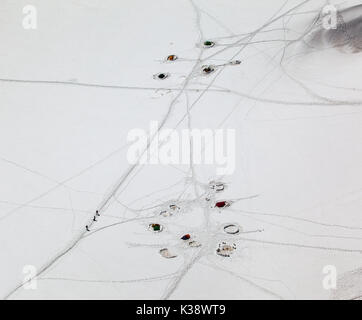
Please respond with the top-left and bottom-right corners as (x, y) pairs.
(0, 0), (362, 299)
